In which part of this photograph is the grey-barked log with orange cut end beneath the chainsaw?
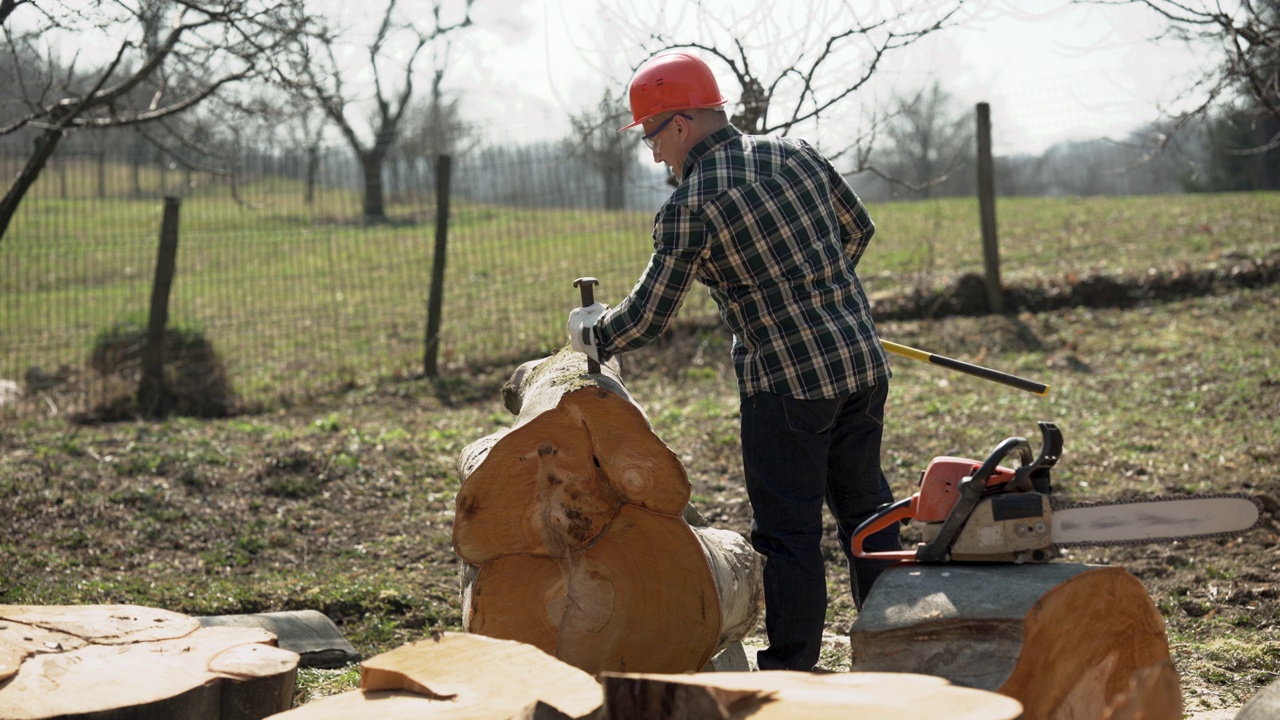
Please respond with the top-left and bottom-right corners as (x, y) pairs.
(850, 562), (1181, 720)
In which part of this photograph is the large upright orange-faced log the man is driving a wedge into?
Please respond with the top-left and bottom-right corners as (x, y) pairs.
(453, 348), (762, 673)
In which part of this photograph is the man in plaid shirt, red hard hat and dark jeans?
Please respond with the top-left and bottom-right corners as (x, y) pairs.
(568, 53), (900, 670)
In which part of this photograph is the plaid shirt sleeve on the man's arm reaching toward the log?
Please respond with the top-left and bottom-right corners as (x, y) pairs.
(595, 199), (707, 359)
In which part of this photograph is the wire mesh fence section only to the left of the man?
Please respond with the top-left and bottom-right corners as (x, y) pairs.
(0, 126), (712, 418)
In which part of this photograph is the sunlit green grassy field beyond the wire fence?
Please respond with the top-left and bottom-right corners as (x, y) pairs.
(0, 187), (1280, 402)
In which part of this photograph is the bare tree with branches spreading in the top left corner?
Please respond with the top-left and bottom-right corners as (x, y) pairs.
(0, 0), (298, 237)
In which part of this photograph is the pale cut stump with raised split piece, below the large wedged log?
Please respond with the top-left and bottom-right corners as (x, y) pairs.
(278, 633), (603, 720)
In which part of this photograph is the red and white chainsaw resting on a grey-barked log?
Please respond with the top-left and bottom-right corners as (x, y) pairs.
(850, 421), (1261, 562)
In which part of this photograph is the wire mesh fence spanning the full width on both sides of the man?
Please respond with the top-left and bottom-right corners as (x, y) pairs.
(0, 117), (1280, 421)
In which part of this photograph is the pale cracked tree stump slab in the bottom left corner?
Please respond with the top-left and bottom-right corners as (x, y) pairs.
(0, 605), (298, 720)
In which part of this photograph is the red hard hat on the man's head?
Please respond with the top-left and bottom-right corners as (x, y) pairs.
(618, 53), (728, 132)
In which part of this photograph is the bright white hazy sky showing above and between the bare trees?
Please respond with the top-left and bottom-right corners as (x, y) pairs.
(24, 0), (1219, 154)
